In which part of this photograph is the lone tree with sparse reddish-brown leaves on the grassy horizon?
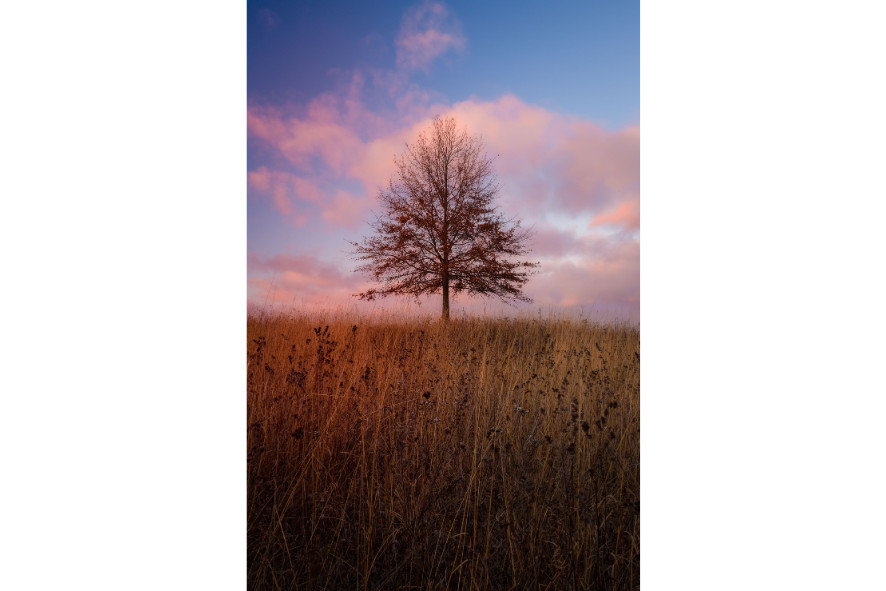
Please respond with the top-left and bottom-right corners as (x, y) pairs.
(350, 117), (538, 321)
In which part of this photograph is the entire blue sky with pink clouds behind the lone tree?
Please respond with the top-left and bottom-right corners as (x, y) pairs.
(247, 1), (640, 321)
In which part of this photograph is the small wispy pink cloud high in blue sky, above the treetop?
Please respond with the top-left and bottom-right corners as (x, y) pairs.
(396, 2), (468, 72)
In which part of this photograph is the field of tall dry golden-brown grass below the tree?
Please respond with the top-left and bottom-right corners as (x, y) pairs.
(247, 315), (640, 590)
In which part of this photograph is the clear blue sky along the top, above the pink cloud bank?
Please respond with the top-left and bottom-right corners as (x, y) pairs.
(247, 0), (640, 128)
